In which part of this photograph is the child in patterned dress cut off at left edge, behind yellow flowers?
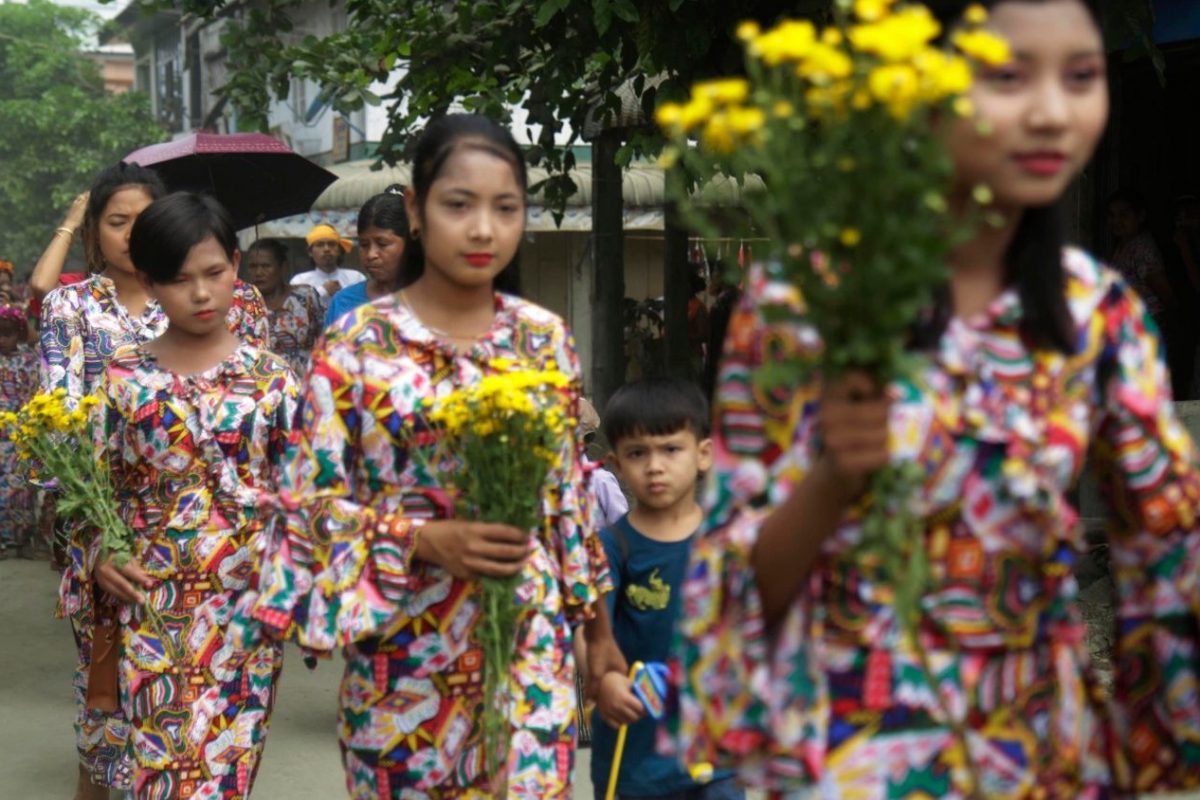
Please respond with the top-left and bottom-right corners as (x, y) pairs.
(0, 306), (37, 559)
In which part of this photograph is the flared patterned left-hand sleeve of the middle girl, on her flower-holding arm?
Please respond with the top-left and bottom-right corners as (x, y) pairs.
(242, 335), (427, 651)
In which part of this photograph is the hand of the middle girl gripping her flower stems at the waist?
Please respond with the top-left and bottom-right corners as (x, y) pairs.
(416, 519), (530, 581)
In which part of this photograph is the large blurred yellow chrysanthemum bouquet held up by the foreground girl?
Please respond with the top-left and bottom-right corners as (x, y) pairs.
(658, 0), (1009, 632)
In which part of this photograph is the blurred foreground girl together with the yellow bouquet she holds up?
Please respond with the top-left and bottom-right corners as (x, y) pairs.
(666, 0), (1200, 800)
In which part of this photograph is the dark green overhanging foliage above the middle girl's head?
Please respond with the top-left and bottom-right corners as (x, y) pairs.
(112, 0), (811, 207)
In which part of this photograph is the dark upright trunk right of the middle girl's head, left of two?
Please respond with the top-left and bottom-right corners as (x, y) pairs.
(592, 131), (625, 409)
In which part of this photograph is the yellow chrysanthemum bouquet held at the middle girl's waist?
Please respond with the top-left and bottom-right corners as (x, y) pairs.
(427, 367), (575, 776)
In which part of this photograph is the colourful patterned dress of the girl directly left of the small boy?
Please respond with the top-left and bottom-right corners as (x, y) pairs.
(237, 295), (610, 800)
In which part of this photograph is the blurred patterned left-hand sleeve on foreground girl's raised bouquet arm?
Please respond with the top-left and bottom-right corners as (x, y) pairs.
(664, 267), (827, 787)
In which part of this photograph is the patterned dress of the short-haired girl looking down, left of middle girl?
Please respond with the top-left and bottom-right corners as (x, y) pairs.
(88, 342), (298, 800)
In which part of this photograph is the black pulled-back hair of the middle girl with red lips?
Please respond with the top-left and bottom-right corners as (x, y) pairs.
(398, 114), (528, 294)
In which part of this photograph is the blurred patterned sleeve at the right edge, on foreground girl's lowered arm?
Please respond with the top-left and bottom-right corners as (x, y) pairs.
(1092, 281), (1200, 794)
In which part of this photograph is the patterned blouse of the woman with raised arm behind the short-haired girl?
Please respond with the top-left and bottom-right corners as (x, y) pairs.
(41, 275), (269, 398)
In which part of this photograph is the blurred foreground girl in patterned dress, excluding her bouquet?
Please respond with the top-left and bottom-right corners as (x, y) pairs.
(674, 0), (1200, 800)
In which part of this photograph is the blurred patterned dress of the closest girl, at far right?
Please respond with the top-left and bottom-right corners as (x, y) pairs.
(674, 251), (1200, 800)
